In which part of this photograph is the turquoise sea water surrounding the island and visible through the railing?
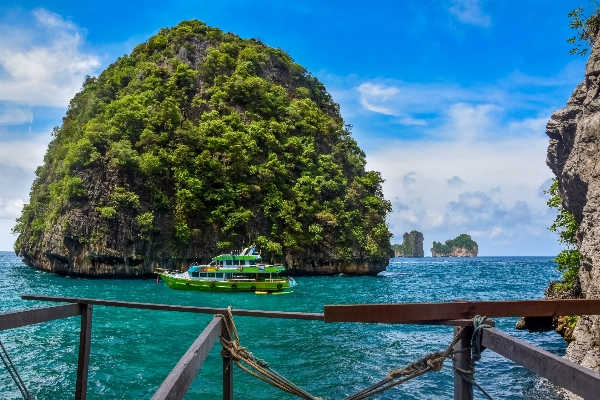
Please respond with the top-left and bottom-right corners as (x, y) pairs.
(0, 252), (566, 399)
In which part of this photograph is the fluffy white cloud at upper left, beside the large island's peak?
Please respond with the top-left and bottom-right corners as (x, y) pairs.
(0, 9), (100, 107)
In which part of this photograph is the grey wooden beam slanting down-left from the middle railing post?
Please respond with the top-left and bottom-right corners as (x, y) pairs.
(152, 317), (223, 400)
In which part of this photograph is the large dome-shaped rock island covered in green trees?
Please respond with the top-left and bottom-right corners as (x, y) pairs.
(14, 20), (391, 268)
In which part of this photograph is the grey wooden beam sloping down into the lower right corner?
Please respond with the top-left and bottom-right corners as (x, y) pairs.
(481, 328), (600, 399)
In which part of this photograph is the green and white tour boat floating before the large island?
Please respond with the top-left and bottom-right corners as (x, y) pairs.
(157, 248), (296, 293)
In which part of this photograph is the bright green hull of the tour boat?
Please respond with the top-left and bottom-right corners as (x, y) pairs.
(159, 274), (291, 292)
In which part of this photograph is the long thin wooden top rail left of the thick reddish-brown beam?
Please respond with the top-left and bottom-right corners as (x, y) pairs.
(21, 295), (323, 321)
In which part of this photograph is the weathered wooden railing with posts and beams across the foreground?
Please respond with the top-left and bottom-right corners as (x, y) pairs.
(0, 295), (600, 400)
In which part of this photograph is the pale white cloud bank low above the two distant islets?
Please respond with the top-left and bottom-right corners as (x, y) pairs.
(367, 119), (553, 255)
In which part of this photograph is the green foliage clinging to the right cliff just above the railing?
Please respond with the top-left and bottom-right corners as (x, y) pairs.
(545, 178), (581, 291)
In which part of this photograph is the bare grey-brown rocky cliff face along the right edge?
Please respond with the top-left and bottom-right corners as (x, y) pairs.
(546, 42), (600, 380)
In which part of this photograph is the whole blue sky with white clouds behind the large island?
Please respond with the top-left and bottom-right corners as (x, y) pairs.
(0, 0), (591, 256)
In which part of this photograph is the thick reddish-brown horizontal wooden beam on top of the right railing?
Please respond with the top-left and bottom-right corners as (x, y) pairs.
(325, 299), (600, 324)
